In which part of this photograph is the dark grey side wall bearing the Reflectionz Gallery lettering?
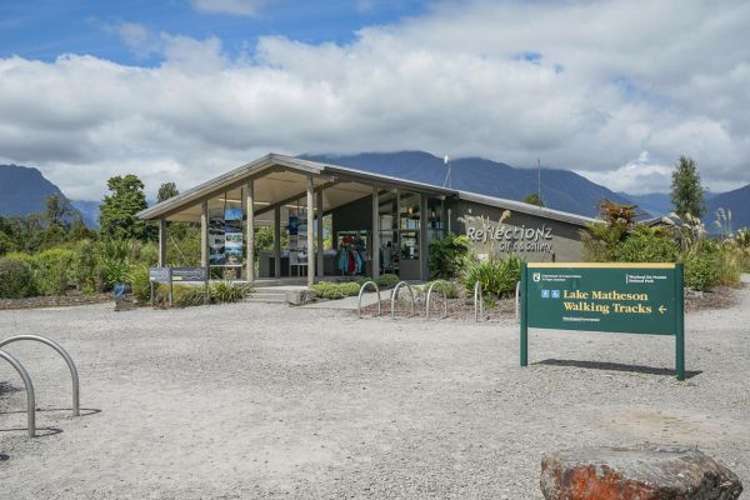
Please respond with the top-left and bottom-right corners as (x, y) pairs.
(449, 200), (583, 262)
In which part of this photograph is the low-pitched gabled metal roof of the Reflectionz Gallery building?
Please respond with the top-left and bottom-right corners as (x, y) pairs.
(138, 153), (598, 226)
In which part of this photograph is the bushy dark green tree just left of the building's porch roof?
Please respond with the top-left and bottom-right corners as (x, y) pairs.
(99, 174), (153, 239)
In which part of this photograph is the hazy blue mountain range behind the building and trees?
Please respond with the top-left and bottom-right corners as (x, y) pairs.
(0, 151), (750, 228)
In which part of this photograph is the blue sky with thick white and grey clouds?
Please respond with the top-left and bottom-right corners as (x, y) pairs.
(0, 0), (750, 199)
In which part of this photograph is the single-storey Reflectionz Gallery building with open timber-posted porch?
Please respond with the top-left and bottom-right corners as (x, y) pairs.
(138, 154), (595, 283)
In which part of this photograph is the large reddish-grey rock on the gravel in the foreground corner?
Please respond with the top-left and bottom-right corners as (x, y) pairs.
(540, 446), (742, 500)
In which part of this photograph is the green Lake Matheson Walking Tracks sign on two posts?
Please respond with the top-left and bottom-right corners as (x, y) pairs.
(521, 263), (685, 380)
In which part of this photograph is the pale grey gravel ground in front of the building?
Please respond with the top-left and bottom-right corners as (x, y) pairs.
(0, 280), (750, 499)
